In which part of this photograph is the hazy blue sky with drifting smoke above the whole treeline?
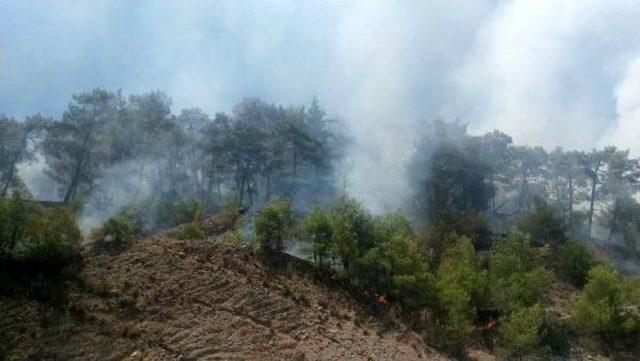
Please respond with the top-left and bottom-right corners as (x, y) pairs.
(0, 0), (640, 211)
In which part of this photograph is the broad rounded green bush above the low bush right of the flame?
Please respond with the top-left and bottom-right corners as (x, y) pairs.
(489, 233), (550, 312)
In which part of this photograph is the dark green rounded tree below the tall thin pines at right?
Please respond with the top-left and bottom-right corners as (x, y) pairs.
(518, 202), (567, 246)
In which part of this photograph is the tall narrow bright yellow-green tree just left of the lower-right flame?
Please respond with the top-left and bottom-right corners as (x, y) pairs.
(437, 237), (487, 342)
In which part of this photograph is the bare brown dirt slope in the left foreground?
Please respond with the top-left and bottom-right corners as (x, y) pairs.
(0, 239), (444, 360)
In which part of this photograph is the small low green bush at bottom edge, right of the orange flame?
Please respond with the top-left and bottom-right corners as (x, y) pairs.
(498, 303), (550, 359)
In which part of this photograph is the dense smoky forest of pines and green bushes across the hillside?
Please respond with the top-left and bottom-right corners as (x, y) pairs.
(0, 89), (640, 359)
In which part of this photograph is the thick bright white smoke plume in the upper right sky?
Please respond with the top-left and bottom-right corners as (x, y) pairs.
(452, 0), (640, 148)
